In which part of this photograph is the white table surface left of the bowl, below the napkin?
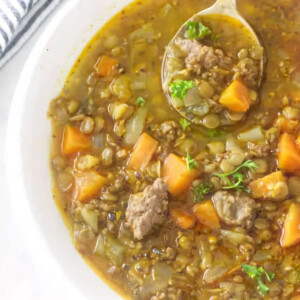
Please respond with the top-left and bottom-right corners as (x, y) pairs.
(0, 5), (84, 300)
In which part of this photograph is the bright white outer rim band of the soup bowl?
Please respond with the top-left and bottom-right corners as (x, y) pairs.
(4, 0), (120, 299)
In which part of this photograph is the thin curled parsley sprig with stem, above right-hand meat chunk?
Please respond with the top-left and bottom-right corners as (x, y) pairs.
(214, 160), (257, 193)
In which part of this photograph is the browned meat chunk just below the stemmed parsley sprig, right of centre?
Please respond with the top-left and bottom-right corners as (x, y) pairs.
(213, 191), (257, 229)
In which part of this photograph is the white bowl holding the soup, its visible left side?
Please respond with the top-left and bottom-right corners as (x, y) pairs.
(5, 0), (131, 299)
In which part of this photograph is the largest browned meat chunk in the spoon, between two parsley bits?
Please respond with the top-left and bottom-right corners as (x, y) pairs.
(175, 38), (232, 74)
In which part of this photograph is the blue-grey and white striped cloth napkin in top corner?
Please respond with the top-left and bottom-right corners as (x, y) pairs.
(0, 0), (62, 69)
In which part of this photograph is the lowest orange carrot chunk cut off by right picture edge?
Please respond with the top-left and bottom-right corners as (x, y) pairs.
(280, 203), (300, 248)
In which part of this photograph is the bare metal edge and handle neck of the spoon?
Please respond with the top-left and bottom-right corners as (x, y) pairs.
(161, 0), (264, 123)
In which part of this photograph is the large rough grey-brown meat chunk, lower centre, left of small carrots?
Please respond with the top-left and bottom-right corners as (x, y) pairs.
(126, 178), (169, 240)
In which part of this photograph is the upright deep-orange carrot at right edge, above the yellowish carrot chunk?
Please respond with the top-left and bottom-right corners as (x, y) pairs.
(278, 133), (300, 173)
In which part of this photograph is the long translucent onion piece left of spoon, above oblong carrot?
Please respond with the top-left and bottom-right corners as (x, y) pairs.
(124, 107), (148, 145)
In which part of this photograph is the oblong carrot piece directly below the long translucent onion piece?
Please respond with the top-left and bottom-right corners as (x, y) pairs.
(128, 133), (158, 170)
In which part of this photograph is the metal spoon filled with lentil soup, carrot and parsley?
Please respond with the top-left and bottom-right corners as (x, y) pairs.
(162, 0), (264, 129)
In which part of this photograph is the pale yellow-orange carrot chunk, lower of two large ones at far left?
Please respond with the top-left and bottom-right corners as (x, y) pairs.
(75, 171), (107, 203)
